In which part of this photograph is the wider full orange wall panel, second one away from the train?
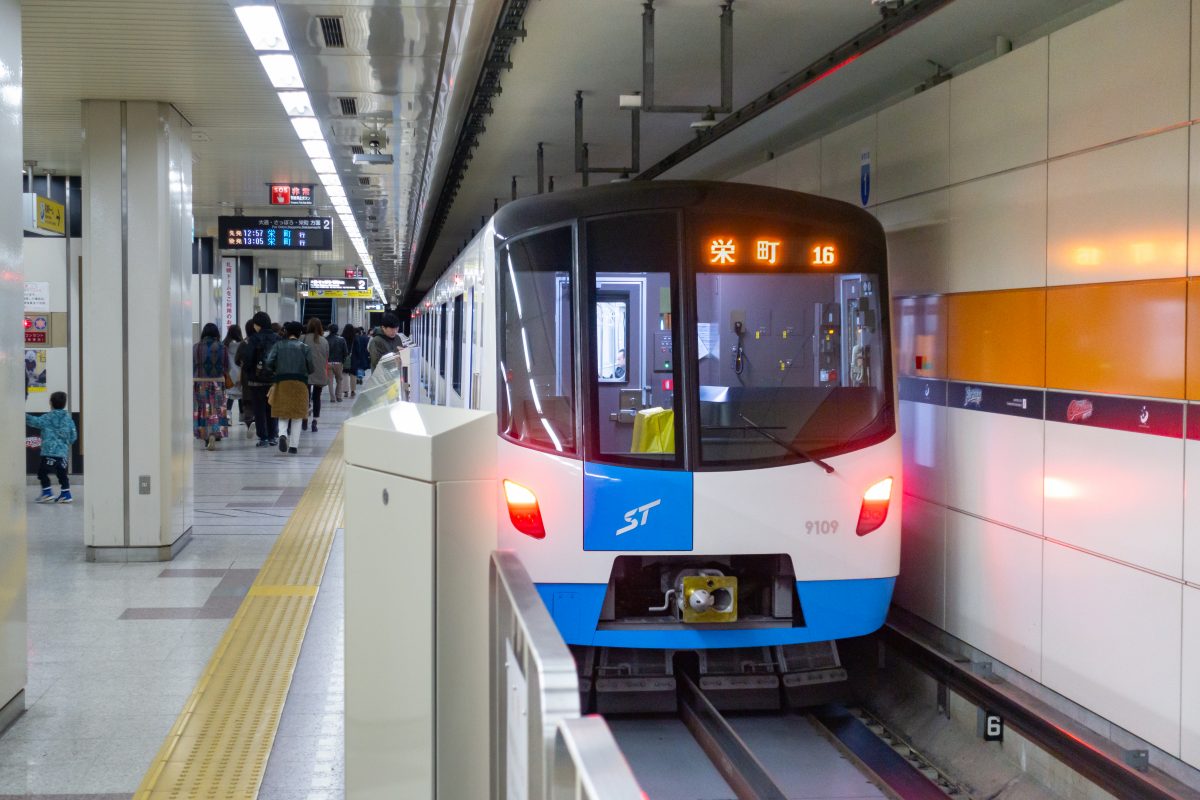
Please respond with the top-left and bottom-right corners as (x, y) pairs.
(1046, 278), (1187, 399)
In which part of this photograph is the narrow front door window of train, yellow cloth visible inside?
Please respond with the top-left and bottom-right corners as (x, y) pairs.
(584, 212), (683, 468)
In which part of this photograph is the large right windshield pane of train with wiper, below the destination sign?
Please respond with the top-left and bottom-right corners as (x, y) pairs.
(696, 272), (889, 465)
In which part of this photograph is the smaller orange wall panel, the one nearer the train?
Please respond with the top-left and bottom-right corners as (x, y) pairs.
(947, 289), (1046, 386)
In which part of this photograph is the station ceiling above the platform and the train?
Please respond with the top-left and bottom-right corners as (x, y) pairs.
(23, 0), (1112, 299)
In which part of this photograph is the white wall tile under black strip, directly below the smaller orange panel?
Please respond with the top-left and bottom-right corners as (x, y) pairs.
(946, 408), (1045, 534)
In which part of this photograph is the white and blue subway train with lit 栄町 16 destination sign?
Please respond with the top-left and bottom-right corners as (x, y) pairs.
(410, 181), (900, 650)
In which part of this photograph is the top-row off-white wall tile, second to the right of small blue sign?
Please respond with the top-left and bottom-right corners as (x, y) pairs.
(949, 38), (1049, 184)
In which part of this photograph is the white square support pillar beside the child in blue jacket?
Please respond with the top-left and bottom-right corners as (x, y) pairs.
(83, 100), (193, 561)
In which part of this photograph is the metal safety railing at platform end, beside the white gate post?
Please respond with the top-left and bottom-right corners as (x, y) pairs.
(488, 552), (642, 800)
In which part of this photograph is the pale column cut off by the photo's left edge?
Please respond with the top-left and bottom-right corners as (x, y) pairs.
(0, 0), (28, 730)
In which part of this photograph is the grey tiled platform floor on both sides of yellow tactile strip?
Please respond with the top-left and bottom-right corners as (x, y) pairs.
(0, 402), (350, 800)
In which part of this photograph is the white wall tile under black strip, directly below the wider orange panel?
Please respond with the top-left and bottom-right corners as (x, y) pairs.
(1045, 422), (1183, 578)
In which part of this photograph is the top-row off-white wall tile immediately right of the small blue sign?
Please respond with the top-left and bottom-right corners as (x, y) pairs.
(876, 82), (950, 203)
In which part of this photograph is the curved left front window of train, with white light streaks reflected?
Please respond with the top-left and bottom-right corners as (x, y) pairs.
(497, 228), (576, 453)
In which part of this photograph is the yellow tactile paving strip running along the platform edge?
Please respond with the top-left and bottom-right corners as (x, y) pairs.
(133, 434), (342, 800)
